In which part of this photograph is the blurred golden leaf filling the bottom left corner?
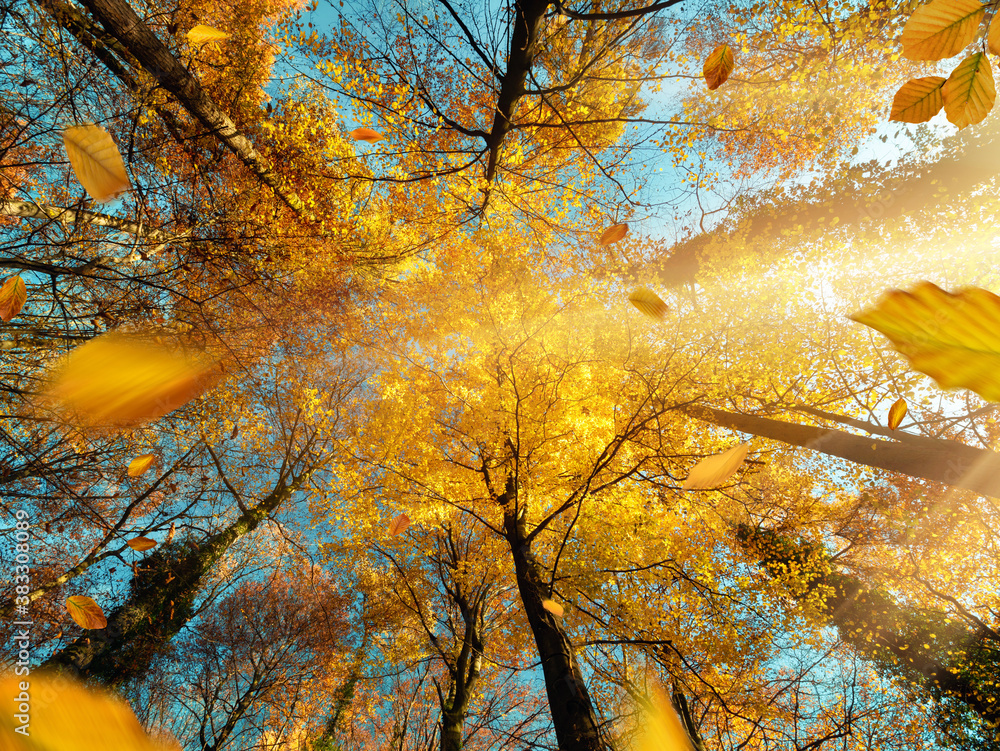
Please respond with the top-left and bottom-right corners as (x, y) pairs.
(0, 671), (180, 751)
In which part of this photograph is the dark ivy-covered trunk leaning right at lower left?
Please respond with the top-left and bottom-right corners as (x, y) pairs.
(42, 475), (306, 686)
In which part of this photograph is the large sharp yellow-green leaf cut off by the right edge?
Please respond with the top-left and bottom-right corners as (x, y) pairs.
(851, 282), (1000, 402)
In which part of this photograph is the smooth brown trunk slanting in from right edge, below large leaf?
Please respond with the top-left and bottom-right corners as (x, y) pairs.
(683, 405), (1000, 498)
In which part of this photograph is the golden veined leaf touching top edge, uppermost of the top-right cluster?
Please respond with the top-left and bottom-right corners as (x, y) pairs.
(900, 0), (986, 60)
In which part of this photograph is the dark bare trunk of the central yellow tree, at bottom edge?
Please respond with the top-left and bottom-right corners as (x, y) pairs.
(497, 476), (608, 751)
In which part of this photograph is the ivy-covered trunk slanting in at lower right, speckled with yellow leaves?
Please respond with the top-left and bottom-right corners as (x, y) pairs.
(736, 525), (1000, 724)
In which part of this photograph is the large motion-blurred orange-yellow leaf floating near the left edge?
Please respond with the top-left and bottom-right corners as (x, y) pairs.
(46, 333), (219, 428)
